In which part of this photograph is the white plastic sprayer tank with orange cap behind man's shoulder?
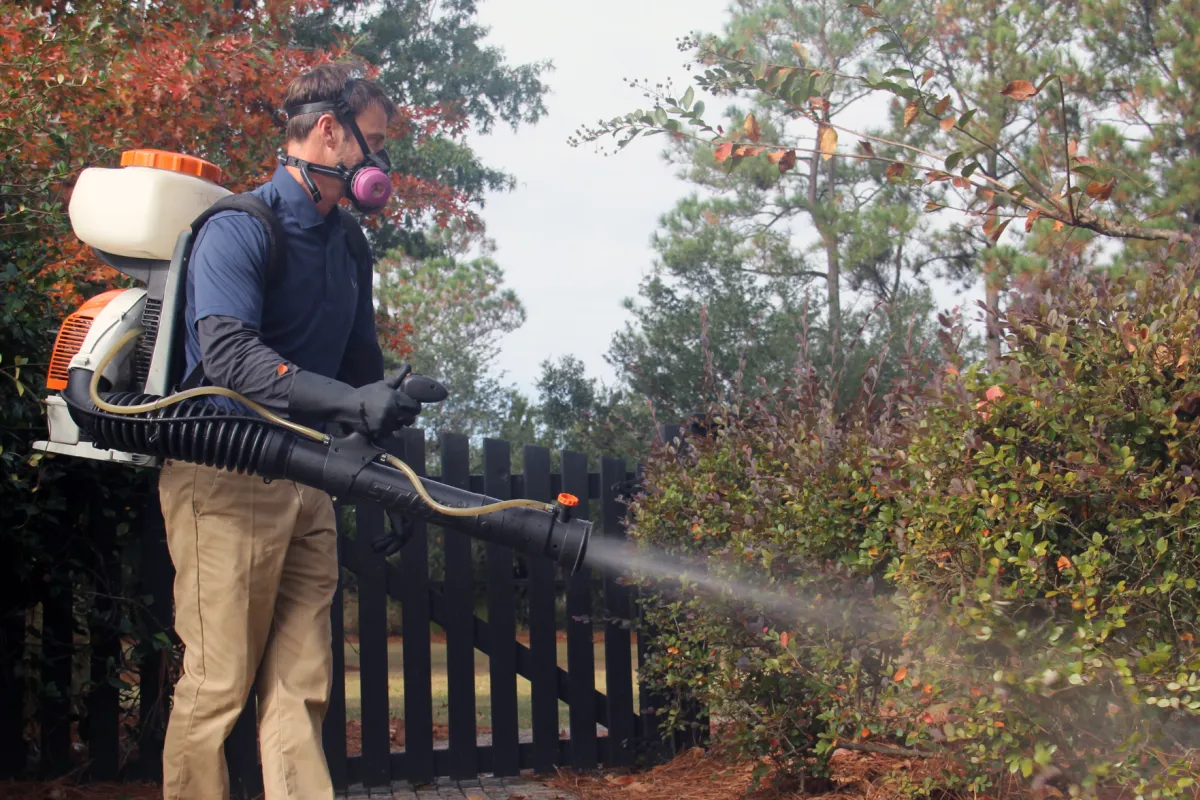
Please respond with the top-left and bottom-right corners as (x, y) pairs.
(67, 150), (230, 260)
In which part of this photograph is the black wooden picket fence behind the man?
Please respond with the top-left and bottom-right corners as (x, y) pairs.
(0, 431), (698, 796)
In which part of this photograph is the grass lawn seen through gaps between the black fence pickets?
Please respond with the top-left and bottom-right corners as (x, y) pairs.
(346, 640), (637, 729)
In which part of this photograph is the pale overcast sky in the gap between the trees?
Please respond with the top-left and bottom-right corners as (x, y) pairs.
(468, 0), (979, 396)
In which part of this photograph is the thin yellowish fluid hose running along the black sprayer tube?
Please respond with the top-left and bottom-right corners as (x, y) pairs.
(89, 327), (554, 517)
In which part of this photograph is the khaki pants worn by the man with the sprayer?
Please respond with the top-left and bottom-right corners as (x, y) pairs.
(158, 462), (337, 800)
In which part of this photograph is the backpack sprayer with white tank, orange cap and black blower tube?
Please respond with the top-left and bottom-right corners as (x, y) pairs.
(34, 150), (592, 575)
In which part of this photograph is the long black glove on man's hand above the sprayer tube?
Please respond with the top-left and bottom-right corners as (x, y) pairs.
(288, 369), (421, 438)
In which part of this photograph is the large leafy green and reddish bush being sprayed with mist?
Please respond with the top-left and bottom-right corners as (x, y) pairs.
(630, 254), (1200, 798)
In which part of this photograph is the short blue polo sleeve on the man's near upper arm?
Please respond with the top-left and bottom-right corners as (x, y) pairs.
(187, 211), (270, 330)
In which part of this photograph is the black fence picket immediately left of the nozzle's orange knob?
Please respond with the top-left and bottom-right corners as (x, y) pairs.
(524, 445), (558, 774)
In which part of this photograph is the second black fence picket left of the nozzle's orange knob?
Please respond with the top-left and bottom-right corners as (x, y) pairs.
(484, 439), (521, 777)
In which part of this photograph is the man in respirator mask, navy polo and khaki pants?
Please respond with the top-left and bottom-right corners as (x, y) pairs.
(160, 66), (420, 800)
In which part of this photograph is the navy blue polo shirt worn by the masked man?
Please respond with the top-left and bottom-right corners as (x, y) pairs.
(185, 166), (383, 386)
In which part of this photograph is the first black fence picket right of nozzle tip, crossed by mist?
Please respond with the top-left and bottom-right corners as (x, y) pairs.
(600, 457), (634, 766)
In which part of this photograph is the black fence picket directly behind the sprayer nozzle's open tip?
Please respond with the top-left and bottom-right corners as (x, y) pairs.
(563, 450), (599, 770)
